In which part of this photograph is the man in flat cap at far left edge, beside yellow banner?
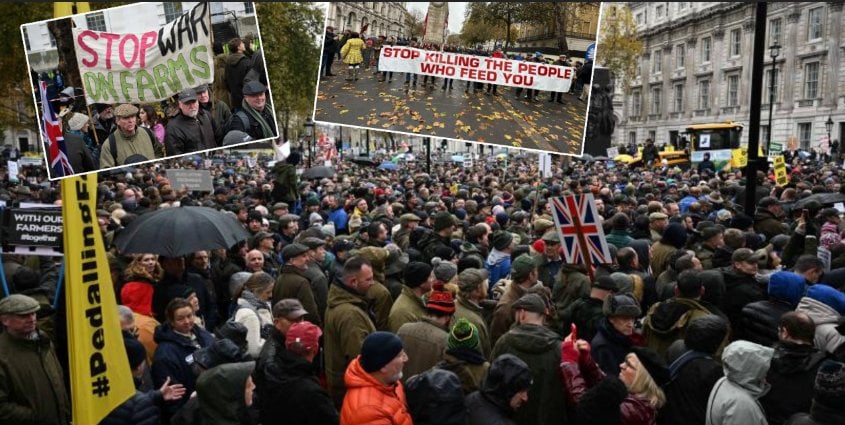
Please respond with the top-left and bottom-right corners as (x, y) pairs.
(0, 294), (70, 425)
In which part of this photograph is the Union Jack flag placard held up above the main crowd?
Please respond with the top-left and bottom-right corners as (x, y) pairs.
(551, 193), (612, 267)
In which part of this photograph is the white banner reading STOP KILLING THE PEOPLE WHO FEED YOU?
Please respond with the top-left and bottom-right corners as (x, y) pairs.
(378, 46), (575, 92)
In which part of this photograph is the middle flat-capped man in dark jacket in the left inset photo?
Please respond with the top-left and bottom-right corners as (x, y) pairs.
(164, 88), (220, 155)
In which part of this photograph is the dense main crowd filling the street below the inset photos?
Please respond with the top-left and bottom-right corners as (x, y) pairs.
(0, 138), (845, 425)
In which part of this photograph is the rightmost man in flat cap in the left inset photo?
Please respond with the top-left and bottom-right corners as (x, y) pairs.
(226, 81), (278, 140)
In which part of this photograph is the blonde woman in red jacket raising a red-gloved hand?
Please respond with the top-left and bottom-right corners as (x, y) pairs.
(560, 334), (669, 425)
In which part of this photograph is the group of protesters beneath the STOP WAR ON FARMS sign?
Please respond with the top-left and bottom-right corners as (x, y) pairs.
(35, 36), (278, 173)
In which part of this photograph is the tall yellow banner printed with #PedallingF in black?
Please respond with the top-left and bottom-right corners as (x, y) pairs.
(61, 174), (135, 425)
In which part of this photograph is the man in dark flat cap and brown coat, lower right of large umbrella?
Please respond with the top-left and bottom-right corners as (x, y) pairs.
(273, 242), (323, 325)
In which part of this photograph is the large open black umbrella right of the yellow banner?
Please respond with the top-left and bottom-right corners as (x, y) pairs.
(114, 207), (249, 257)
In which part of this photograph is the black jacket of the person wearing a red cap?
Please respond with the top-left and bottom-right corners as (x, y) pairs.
(259, 347), (340, 425)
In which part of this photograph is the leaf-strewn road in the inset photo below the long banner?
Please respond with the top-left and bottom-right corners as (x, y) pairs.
(315, 63), (587, 155)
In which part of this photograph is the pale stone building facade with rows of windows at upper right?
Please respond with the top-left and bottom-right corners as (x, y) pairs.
(612, 2), (845, 149)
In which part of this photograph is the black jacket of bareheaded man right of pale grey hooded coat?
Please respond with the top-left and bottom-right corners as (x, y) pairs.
(760, 342), (825, 425)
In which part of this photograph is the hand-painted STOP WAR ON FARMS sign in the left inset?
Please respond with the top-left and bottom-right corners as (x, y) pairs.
(73, 2), (214, 104)
